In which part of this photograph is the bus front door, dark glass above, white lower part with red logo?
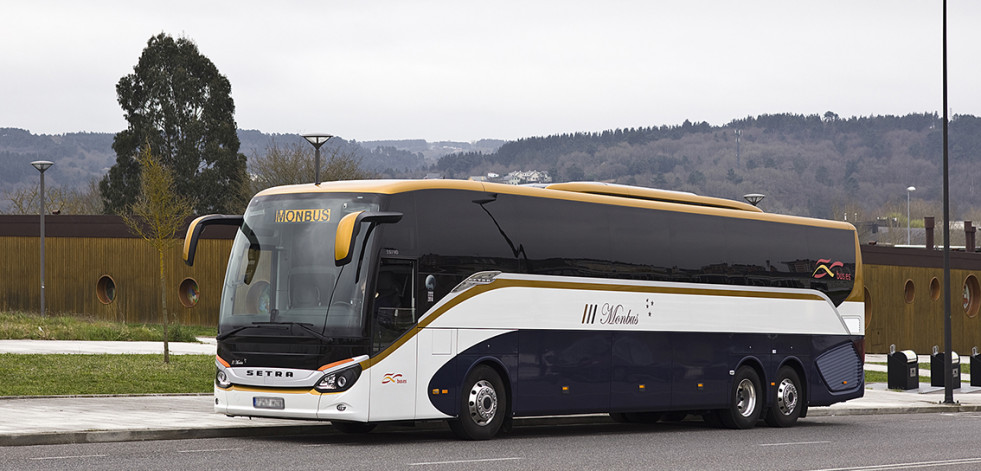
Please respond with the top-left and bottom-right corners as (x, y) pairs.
(368, 259), (419, 422)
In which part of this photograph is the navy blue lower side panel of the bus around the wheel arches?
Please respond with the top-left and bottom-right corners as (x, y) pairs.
(430, 330), (864, 416)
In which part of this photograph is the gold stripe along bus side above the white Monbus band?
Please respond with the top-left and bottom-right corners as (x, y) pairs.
(360, 279), (827, 369)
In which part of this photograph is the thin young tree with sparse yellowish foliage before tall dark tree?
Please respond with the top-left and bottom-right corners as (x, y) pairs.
(122, 143), (194, 363)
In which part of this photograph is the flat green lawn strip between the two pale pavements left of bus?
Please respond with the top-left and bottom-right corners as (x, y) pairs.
(0, 353), (215, 396)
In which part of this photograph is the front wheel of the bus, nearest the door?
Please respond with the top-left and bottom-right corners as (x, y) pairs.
(450, 365), (508, 440)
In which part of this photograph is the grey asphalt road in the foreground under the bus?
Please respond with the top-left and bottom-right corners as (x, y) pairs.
(0, 413), (981, 471)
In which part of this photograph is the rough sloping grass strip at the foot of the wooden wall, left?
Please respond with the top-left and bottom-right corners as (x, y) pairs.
(0, 312), (217, 342)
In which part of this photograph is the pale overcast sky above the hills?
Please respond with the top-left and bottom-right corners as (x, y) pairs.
(0, 0), (981, 141)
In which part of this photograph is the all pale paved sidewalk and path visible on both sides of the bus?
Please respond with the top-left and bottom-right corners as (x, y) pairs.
(0, 340), (981, 446)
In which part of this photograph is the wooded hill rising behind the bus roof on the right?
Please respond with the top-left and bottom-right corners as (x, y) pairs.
(437, 112), (981, 219)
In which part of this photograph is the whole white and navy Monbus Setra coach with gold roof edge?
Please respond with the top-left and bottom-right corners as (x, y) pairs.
(184, 180), (864, 439)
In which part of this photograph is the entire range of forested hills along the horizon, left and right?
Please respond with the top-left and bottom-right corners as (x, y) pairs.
(0, 112), (981, 221)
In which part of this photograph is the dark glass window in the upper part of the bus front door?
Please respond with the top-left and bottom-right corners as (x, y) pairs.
(372, 260), (416, 353)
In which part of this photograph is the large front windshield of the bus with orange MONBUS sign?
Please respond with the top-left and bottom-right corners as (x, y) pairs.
(218, 193), (378, 338)
